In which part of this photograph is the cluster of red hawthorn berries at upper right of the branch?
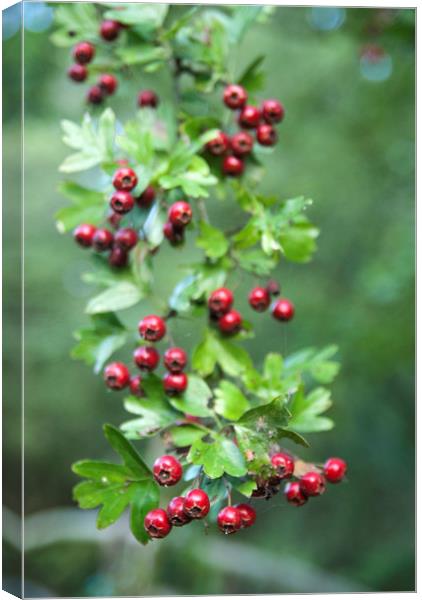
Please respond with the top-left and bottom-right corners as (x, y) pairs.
(206, 84), (284, 177)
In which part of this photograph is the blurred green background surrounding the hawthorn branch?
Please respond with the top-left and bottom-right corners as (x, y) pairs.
(3, 3), (415, 596)
